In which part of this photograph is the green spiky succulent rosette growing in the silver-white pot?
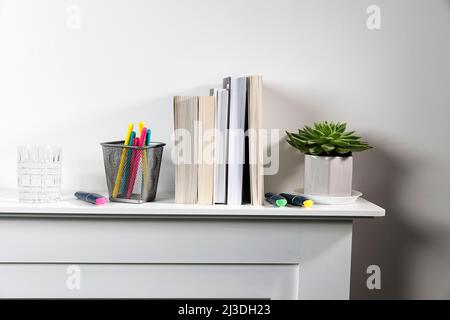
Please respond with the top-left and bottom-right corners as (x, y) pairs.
(286, 121), (372, 157)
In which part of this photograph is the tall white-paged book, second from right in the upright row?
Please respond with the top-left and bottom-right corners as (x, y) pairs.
(223, 77), (247, 205)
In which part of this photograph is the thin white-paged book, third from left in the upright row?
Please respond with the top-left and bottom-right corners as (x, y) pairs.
(211, 89), (229, 204)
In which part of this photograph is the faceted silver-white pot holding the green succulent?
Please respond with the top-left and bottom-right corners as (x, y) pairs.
(304, 155), (353, 197)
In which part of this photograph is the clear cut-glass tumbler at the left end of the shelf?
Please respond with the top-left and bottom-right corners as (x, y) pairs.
(17, 146), (62, 203)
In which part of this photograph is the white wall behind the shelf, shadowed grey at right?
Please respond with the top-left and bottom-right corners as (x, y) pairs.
(0, 0), (450, 298)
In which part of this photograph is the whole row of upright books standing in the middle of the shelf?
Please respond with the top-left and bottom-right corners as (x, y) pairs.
(174, 76), (264, 205)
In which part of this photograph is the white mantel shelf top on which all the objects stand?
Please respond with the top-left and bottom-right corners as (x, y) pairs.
(0, 193), (385, 219)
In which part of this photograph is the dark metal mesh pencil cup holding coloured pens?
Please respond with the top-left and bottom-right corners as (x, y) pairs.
(101, 141), (166, 203)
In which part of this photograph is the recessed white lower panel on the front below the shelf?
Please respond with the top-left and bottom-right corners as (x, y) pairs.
(0, 263), (299, 299)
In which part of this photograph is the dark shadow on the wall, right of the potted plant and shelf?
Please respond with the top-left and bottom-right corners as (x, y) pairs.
(351, 144), (431, 299)
